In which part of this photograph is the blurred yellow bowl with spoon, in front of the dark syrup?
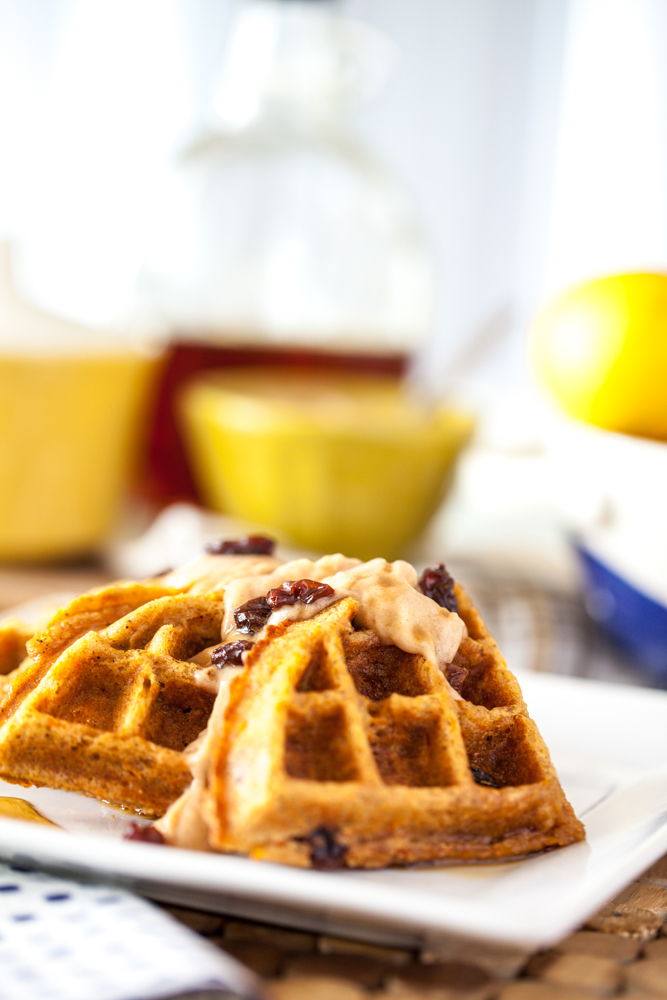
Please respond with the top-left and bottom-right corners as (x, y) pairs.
(180, 368), (474, 559)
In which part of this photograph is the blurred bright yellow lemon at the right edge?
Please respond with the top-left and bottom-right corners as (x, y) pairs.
(531, 274), (667, 440)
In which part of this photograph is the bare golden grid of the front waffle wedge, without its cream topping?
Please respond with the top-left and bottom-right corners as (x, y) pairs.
(190, 588), (584, 868)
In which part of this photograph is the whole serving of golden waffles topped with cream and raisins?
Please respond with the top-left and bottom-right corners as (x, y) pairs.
(0, 538), (584, 868)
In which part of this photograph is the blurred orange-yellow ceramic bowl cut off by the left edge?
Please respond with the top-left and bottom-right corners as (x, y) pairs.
(0, 348), (156, 560)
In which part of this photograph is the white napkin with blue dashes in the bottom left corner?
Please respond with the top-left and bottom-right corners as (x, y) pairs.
(0, 864), (262, 1000)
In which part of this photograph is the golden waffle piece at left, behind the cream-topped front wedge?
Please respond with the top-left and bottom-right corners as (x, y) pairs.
(0, 583), (223, 816)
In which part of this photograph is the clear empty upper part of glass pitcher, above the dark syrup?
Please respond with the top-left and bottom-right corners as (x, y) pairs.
(142, 0), (433, 353)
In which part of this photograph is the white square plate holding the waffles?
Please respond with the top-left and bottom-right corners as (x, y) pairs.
(0, 674), (667, 950)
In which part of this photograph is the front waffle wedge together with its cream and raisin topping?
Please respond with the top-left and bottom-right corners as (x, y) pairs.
(154, 557), (584, 868)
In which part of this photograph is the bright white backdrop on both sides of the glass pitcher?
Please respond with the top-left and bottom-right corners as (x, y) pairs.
(0, 0), (667, 389)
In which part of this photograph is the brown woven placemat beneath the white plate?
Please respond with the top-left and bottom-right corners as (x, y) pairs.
(159, 855), (667, 1000)
